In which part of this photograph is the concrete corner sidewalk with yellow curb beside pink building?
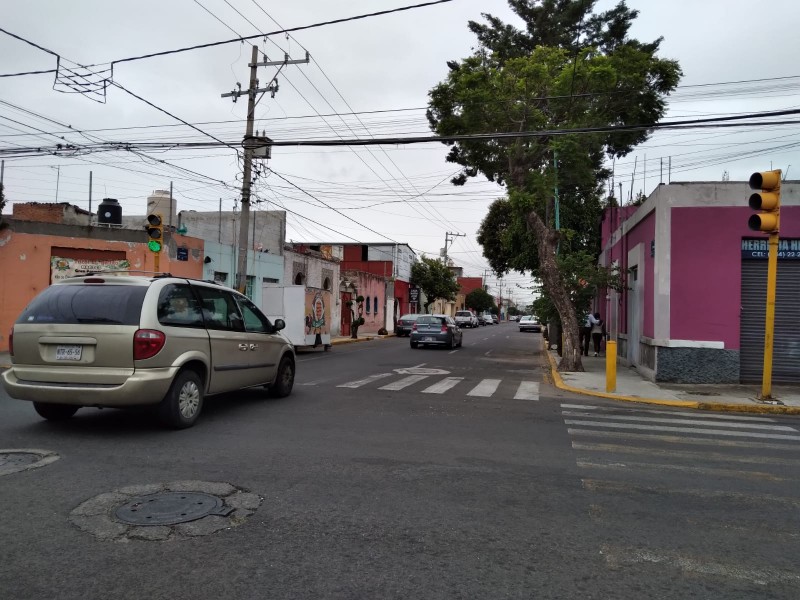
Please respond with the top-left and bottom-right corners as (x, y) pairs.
(547, 350), (800, 414)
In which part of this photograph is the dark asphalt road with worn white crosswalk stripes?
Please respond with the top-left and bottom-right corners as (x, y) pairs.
(0, 324), (800, 600)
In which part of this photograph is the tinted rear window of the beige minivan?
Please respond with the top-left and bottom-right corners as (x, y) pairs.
(17, 284), (147, 325)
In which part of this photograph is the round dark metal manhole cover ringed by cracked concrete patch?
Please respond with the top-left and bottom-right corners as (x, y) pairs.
(114, 492), (233, 525)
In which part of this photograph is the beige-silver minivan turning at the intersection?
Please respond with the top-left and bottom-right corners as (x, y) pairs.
(2, 273), (295, 428)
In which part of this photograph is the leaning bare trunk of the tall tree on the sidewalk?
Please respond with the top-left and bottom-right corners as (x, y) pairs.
(528, 211), (583, 371)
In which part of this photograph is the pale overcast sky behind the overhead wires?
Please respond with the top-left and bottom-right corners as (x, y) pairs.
(0, 0), (800, 300)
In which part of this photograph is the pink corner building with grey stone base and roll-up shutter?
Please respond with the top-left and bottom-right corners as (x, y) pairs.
(595, 182), (800, 383)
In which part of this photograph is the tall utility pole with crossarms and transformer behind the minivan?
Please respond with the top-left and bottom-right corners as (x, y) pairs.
(222, 46), (310, 293)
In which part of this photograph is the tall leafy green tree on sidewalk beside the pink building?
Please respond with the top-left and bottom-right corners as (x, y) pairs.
(428, 0), (681, 370)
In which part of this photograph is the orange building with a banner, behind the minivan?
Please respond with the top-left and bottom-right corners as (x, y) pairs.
(0, 203), (205, 352)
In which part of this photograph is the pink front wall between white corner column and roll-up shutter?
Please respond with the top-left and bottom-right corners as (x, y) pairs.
(668, 206), (800, 349)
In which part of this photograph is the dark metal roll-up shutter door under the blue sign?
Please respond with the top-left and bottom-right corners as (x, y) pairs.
(739, 260), (800, 383)
